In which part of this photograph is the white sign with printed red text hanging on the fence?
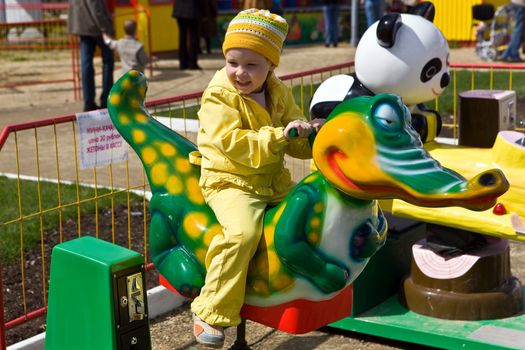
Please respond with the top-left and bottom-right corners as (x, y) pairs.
(76, 109), (128, 169)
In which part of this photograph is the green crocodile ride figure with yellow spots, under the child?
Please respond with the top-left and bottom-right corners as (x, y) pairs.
(108, 71), (509, 324)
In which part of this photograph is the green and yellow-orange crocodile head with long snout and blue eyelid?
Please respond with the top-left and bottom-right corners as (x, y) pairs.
(313, 94), (509, 210)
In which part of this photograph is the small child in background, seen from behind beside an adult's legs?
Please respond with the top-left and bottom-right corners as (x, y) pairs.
(104, 19), (148, 74)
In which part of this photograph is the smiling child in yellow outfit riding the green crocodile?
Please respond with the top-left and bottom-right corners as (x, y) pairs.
(191, 9), (322, 347)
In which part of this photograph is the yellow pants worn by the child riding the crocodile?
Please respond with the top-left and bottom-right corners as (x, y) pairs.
(191, 186), (284, 327)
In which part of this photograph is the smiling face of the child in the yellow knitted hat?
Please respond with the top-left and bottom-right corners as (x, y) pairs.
(226, 49), (274, 95)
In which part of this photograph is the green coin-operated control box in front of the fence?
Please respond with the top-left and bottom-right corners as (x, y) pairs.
(45, 236), (151, 350)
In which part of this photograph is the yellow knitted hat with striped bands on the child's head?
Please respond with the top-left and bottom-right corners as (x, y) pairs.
(222, 8), (288, 66)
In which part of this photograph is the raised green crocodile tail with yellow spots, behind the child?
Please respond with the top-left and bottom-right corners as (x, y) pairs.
(108, 70), (200, 196)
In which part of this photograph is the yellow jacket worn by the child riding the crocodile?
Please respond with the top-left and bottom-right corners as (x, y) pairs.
(197, 68), (311, 196)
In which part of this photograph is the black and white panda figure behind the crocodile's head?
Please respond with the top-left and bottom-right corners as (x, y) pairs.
(310, 2), (450, 142)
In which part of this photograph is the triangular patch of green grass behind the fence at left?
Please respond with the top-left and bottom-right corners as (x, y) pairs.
(0, 176), (142, 264)
